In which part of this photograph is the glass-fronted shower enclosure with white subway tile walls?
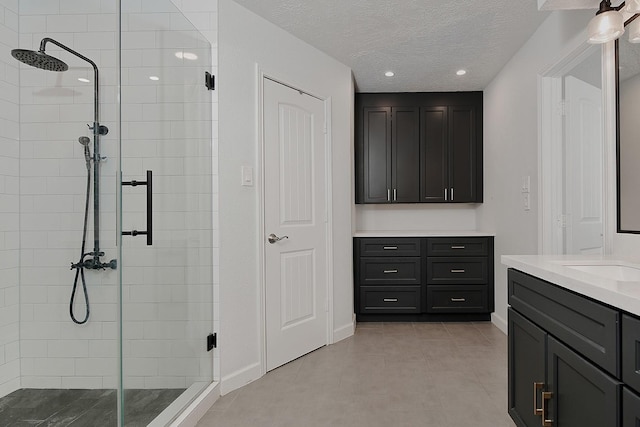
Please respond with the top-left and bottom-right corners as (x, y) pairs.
(0, 0), (215, 426)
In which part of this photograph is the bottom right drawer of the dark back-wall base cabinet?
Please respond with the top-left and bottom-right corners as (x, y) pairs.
(427, 285), (489, 313)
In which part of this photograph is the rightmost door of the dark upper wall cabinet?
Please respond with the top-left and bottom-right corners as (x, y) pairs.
(448, 106), (477, 202)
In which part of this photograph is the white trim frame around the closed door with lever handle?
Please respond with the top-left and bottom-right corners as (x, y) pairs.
(256, 64), (333, 375)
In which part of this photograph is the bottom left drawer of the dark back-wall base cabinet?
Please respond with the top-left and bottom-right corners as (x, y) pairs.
(360, 286), (420, 314)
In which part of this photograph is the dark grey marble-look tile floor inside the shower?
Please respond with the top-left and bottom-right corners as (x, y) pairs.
(0, 389), (184, 427)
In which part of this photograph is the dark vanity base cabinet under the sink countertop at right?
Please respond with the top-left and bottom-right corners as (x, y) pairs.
(508, 269), (640, 427)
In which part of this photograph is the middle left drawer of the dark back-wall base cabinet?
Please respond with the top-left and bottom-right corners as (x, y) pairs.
(360, 257), (421, 285)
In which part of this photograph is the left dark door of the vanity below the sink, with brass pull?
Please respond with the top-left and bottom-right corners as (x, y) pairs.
(508, 308), (547, 427)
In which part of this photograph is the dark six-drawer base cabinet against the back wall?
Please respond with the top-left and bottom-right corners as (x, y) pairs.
(354, 237), (494, 322)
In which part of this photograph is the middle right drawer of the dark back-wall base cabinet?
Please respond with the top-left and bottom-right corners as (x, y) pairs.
(427, 257), (488, 285)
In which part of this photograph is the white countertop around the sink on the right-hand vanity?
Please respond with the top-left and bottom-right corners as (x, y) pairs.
(501, 255), (640, 316)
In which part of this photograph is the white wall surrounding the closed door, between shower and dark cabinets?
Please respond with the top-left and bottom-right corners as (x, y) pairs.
(218, 0), (353, 393)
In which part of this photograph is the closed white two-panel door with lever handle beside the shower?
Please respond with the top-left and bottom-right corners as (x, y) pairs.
(263, 78), (327, 370)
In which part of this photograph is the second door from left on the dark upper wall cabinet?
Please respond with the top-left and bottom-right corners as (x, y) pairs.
(391, 107), (420, 203)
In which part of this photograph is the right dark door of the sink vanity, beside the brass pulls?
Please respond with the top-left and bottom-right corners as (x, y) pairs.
(543, 336), (622, 427)
